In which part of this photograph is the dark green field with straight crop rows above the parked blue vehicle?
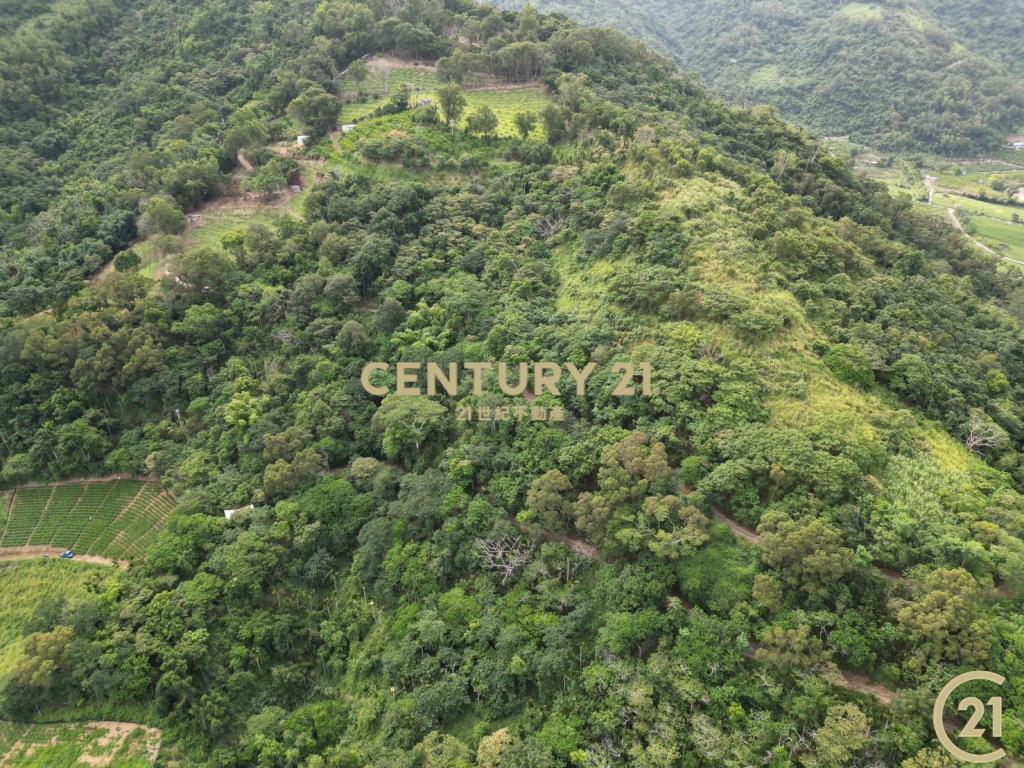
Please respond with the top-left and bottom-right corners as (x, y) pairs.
(0, 479), (174, 560)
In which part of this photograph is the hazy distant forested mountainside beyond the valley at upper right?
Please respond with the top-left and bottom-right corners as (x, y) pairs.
(487, 0), (1024, 157)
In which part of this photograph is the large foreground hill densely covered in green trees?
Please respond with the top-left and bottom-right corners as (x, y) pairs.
(0, 0), (1024, 768)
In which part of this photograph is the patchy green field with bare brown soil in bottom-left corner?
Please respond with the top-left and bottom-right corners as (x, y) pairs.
(0, 721), (161, 768)
